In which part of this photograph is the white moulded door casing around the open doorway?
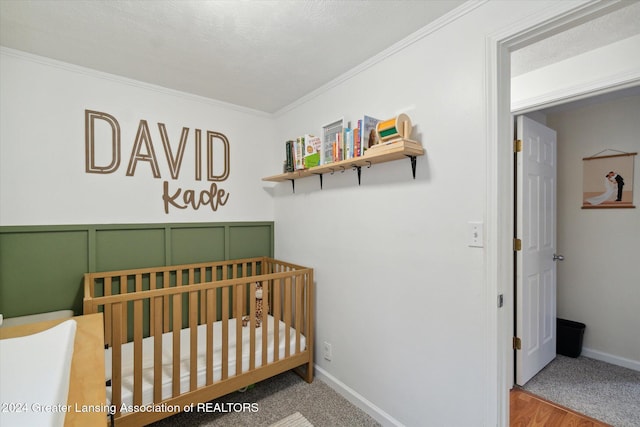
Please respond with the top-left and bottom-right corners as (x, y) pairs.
(486, 2), (640, 425)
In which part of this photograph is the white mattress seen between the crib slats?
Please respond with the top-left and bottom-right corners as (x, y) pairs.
(105, 316), (306, 406)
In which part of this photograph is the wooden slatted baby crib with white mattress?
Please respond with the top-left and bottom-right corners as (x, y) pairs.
(84, 257), (314, 426)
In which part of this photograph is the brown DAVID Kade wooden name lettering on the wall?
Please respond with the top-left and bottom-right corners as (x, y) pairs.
(84, 110), (230, 214)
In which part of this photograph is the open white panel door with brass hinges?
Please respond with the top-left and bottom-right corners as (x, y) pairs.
(515, 116), (557, 385)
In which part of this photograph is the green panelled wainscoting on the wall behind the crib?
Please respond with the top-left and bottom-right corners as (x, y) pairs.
(0, 221), (274, 318)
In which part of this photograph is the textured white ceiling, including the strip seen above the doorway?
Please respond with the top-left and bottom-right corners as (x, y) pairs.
(0, 0), (640, 113)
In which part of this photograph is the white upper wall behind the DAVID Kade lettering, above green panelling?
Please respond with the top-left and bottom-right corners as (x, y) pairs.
(0, 48), (274, 225)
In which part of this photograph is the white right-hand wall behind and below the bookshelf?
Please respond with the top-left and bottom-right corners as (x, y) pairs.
(273, 2), (568, 426)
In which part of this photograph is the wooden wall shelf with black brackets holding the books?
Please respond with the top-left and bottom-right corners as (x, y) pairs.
(262, 139), (424, 191)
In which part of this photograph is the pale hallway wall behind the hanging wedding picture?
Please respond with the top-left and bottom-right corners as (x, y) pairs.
(547, 96), (640, 369)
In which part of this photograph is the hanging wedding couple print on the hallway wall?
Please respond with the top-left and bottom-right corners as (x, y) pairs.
(582, 153), (638, 209)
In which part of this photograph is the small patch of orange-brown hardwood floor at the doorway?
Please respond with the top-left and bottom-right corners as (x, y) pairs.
(509, 388), (611, 427)
